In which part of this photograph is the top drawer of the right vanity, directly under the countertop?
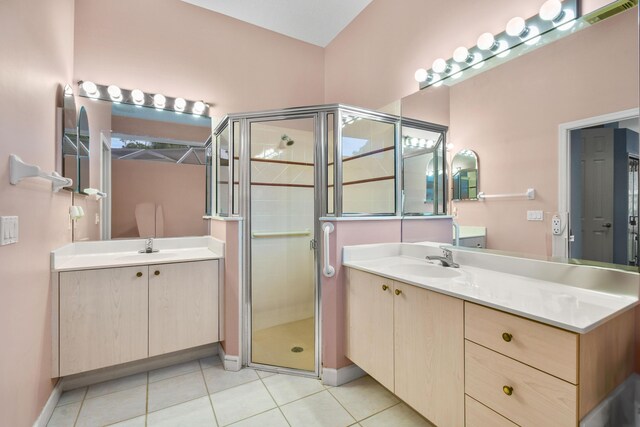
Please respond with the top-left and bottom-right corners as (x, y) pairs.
(465, 303), (578, 384)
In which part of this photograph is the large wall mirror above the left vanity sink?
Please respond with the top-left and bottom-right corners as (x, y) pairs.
(74, 98), (211, 244)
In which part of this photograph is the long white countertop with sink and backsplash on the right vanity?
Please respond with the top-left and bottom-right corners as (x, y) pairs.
(342, 244), (640, 333)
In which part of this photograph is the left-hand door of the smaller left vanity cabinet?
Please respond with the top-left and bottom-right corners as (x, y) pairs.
(60, 266), (148, 376)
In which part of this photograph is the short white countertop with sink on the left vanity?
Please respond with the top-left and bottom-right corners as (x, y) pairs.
(51, 236), (224, 272)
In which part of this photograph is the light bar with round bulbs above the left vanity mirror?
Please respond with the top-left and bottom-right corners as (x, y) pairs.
(78, 81), (209, 116)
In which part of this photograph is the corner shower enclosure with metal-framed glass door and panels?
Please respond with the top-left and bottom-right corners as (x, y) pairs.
(207, 105), (444, 376)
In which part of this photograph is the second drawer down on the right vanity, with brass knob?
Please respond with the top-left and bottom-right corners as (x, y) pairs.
(465, 340), (578, 427)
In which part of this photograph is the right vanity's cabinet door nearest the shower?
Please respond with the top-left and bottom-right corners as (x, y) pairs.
(346, 269), (393, 391)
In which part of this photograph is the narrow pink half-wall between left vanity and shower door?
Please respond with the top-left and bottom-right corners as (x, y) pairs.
(210, 219), (242, 356)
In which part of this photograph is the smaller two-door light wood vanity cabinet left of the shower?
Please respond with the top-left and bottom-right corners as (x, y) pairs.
(53, 260), (218, 376)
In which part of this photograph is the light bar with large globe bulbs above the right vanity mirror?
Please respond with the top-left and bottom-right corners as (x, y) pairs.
(414, 0), (578, 89)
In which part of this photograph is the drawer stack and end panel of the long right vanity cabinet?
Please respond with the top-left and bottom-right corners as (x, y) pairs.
(465, 302), (634, 427)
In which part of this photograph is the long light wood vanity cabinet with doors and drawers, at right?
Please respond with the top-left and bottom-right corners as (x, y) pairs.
(345, 268), (635, 427)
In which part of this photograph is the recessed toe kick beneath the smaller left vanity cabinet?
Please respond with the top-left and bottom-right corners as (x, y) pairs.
(62, 343), (219, 390)
